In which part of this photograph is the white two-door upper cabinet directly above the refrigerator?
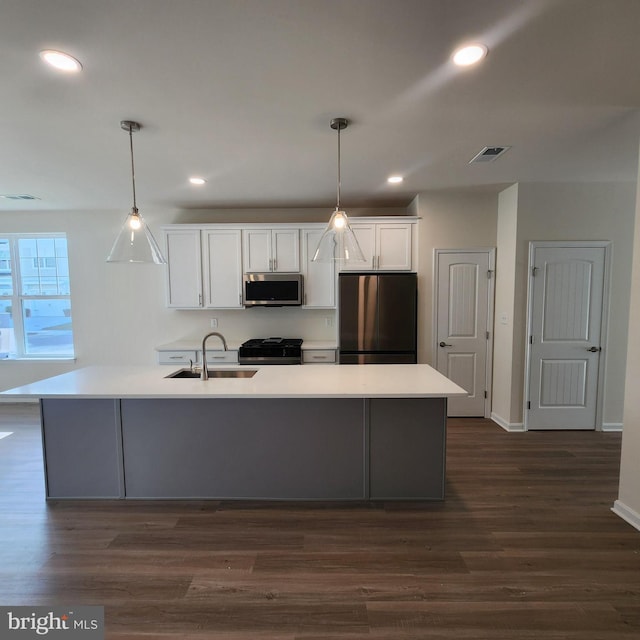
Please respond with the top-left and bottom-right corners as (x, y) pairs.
(340, 222), (415, 271)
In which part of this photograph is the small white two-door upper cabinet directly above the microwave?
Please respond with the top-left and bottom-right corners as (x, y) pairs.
(242, 228), (300, 273)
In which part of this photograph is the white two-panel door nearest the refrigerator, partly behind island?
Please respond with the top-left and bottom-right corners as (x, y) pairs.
(436, 251), (493, 417)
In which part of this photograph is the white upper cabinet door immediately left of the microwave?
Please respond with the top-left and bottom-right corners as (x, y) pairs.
(203, 229), (242, 309)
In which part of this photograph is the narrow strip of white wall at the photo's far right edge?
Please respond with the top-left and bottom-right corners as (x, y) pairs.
(614, 149), (640, 529)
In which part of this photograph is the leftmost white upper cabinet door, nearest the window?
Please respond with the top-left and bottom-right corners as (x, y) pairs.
(165, 229), (202, 309)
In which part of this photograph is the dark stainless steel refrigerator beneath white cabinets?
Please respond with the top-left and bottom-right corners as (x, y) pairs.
(338, 273), (418, 364)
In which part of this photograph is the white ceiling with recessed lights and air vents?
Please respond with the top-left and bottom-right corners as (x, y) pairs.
(0, 0), (640, 213)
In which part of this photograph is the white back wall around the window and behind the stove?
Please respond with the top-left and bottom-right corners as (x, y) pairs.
(0, 207), (407, 390)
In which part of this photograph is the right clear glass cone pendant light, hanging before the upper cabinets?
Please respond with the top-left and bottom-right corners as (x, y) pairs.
(312, 118), (365, 263)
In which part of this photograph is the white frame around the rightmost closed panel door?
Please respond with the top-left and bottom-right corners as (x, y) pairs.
(522, 240), (613, 431)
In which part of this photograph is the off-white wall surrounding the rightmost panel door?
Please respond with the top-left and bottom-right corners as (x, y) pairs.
(494, 183), (636, 427)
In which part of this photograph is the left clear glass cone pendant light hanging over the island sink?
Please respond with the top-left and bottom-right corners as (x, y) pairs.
(107, 120), (166, 264)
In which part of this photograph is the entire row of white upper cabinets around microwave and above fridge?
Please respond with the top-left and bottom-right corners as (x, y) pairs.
(163, 217), (417, 309)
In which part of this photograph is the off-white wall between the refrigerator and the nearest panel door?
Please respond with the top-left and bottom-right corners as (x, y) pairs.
(409, 191), (498, 364)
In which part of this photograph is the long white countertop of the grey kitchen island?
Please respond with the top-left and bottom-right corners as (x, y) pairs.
(2, 364), (467, 399)
